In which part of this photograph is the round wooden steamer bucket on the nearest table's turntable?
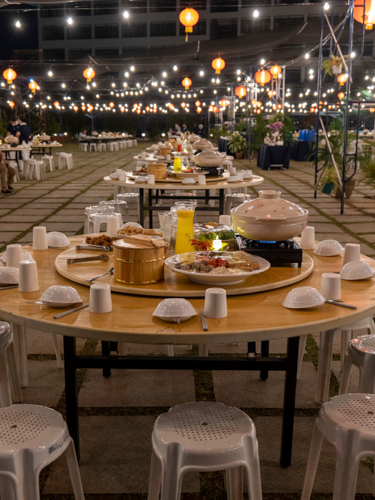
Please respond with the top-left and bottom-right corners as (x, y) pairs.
(113, 240), (167, 285)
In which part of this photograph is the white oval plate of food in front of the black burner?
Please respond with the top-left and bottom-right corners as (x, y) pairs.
(165, 251), (271, 286)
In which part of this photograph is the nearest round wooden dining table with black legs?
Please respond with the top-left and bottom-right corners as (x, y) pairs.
(0, 240), (375, 467)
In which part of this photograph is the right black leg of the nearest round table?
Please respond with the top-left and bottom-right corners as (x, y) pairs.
(280, 337), (299, 467)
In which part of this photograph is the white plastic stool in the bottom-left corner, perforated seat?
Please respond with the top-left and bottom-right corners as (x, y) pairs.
(0, 405), (85, 500)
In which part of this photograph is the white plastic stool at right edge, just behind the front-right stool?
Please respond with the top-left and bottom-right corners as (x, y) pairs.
(339, 335), (375, 394)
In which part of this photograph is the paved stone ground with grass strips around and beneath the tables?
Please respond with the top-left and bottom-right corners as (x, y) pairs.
(0, 144), (375, 500)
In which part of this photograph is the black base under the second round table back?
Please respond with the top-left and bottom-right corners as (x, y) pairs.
(139, 188), (224, 229)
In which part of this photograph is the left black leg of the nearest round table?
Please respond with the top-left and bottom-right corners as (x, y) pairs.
(64, 336), (80, 460)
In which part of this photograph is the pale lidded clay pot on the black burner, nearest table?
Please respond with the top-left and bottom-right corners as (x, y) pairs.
(231, 190), (309, 241)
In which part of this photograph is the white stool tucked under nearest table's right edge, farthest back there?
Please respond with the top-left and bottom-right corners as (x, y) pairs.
(312, 318), (375, 403)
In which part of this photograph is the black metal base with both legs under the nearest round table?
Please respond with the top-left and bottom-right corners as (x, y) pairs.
(64, 336), (299, 467)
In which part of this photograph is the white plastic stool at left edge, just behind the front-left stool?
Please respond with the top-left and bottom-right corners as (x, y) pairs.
(0, 321), (22, 408)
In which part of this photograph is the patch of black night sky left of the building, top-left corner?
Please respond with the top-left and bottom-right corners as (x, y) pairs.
(0, 4), (38, 61)
